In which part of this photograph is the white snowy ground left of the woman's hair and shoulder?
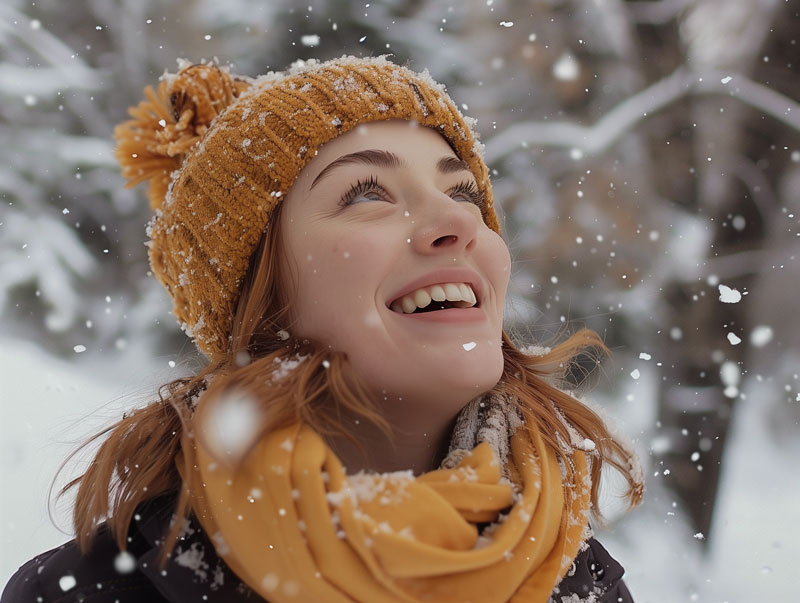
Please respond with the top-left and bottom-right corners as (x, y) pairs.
(0, 338), (177, 585)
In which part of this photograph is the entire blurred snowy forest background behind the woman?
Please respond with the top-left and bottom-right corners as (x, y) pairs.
(0, 0), (800, 602)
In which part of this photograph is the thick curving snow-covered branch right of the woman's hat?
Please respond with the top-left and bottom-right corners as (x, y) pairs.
(486, 68), (800, 163)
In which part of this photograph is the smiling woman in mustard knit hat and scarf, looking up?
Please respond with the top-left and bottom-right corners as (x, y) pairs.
(2, 57), (642, 603)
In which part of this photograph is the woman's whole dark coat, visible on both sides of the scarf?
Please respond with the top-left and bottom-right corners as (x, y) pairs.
(0, 497), (633, 603)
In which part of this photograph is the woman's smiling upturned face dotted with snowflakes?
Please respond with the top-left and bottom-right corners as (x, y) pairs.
(280, 121), (510, 415)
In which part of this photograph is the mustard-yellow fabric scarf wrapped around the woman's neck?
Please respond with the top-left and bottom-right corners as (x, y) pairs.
(183, 424), (590, 603)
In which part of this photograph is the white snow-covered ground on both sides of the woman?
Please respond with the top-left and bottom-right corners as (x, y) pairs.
(0, 338), (800, 603)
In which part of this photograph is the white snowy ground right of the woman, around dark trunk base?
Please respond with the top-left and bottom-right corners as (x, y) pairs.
(599, 378), (800, 603)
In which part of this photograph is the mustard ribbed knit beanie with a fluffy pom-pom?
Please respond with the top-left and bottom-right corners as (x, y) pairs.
(114, 56), (499, 358)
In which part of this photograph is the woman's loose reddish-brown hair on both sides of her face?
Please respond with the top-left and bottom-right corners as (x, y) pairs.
(60, 205), (643, 555)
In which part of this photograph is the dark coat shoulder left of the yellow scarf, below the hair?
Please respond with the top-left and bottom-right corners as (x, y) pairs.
(0, 493), (263, 603)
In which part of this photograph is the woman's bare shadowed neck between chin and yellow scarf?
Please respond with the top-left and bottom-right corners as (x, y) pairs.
(328, 406), (455, 475)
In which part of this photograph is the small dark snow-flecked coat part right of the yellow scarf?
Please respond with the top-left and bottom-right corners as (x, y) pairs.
(549, 538), (633, 603)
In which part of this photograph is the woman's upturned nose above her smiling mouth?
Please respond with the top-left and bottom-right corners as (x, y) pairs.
(411, 191), (480, 255)
